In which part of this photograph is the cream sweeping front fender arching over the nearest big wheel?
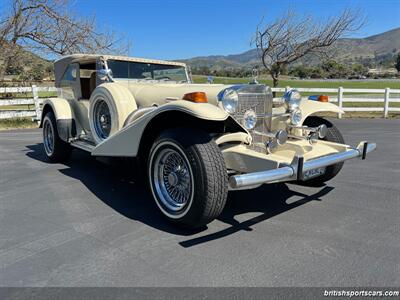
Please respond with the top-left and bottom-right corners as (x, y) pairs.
(92, 100), (234, 157)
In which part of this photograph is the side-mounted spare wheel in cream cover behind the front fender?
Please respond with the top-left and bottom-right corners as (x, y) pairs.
(89, 82), (137, 144)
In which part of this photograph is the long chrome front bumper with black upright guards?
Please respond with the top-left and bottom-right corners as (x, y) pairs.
(229, 142), (376, 189)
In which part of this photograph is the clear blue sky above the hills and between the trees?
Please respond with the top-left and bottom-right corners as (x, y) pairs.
(0, 0), (400, 59)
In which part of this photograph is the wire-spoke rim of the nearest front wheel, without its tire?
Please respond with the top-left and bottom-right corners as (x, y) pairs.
(152, 145), (193, 213)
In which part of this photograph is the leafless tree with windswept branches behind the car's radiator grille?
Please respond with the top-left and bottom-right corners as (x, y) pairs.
(252, 9), (365, 86)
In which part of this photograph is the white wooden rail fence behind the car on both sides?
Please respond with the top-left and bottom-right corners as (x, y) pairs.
(0, 85), (400, 120)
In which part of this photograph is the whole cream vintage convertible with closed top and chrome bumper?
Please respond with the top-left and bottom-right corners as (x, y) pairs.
(41, 54), (376, 227)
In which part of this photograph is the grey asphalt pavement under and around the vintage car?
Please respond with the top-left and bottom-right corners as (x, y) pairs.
(0, 120), (400, 286)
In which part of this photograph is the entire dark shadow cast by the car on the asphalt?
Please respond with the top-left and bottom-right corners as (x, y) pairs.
(26, 143), (333, 247)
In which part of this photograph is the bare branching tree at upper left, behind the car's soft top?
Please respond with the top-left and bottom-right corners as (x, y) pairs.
(0, 0), (129, 76)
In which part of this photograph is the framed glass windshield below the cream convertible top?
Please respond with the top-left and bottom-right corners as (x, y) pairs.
(107, 60), (188, 82)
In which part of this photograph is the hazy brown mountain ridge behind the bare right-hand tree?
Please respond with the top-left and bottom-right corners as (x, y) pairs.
(180, 27), (400, 70)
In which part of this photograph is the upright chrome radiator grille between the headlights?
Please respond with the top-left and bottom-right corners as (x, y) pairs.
(232, 84), (273, 152)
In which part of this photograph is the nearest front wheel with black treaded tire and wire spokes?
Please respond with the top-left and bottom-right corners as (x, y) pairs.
(147, 127), (228, 228)
